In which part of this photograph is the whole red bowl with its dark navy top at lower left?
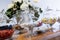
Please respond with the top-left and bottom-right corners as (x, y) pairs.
(0, 25), (14, 40)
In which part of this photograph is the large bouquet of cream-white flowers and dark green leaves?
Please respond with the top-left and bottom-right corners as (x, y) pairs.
(5, 0), (43, 20)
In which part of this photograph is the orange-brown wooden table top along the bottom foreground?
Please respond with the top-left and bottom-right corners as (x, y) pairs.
(17, 32), (54, 40)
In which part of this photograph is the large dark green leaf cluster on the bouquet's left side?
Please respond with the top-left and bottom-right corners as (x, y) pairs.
(5, 1), (23, 18)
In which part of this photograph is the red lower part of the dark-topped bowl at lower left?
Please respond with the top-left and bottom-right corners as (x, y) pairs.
(0, 29), (14, 39)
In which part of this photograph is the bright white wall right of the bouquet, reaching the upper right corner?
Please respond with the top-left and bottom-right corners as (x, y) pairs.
(31, 0), (60, 9)
